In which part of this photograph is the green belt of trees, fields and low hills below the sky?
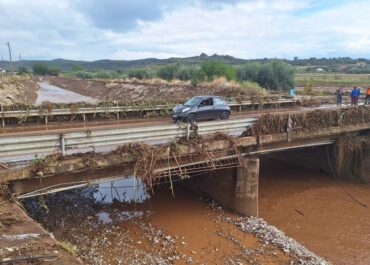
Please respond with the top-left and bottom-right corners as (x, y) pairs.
(12, 54), (370, 90)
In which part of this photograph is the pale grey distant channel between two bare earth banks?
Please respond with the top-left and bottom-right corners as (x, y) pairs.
(36, 82), (97, 104)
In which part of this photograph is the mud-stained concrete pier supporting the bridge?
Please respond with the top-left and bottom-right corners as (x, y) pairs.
(190, 158), (260, 217)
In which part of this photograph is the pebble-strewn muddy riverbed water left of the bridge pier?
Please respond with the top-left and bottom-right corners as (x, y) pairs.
(25, 177), (325, 264)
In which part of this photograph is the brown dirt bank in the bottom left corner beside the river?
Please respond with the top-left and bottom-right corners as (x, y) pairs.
(0, 195), (80, 265)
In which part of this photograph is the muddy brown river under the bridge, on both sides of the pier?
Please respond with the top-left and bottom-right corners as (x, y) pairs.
(21, 158), (370, 265)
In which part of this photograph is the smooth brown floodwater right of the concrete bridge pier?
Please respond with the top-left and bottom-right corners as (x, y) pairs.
(259, 160), (370, 265)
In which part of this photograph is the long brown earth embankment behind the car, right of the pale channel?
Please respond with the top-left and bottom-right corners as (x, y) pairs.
(49, 77), (268, 101)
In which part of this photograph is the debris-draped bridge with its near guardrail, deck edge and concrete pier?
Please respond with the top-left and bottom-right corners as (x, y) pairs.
(0, 106), (370, 216)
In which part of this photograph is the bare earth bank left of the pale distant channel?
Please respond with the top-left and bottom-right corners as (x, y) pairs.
(0, 76), (38, 105)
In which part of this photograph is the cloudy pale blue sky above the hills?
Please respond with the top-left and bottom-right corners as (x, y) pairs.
(0, 0), (370, 61)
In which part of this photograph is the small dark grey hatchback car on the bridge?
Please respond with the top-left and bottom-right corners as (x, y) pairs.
(172, 96), (230, 122)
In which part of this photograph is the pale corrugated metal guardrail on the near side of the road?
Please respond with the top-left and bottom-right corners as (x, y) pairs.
(0, 118), (257, 158)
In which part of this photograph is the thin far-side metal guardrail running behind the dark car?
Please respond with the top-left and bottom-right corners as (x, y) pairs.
(0, 99), (296, 126)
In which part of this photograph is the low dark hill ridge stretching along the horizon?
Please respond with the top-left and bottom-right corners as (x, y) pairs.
(0, 53), (370, 73)
